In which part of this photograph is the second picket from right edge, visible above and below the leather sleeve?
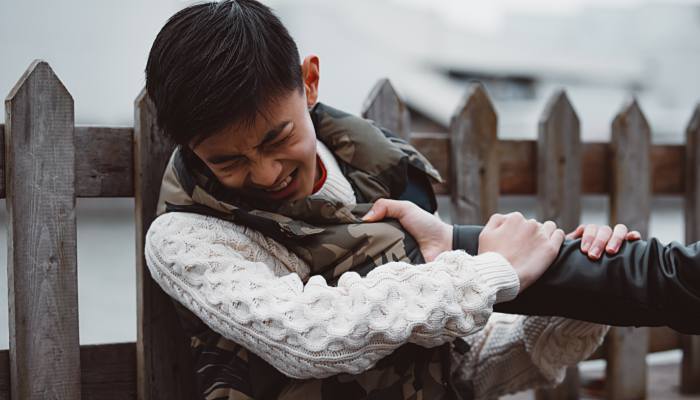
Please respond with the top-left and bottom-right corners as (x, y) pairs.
(606, 100), (651, 400)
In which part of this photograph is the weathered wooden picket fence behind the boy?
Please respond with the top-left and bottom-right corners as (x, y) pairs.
(0, 61), (700, 400)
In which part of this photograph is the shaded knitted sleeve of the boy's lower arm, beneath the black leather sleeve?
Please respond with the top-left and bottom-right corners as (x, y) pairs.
(452, 313), (608, 399)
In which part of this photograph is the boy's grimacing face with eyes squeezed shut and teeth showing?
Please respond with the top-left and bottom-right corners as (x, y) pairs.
(190, 90), (317, 200)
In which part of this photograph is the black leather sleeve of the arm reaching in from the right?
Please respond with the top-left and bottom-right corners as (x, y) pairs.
(453, 225), (700, 334)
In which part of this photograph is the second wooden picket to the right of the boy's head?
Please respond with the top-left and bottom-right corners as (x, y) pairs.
(450, 83), (499, 224)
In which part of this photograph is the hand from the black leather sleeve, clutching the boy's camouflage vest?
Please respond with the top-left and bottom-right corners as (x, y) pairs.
(362, 199), (453, 261)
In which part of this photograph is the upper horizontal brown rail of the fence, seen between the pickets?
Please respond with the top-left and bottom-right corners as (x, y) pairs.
(0, 124), (685, 198)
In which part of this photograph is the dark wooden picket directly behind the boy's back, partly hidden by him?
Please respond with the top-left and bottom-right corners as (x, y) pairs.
(134, 89), (195, 400)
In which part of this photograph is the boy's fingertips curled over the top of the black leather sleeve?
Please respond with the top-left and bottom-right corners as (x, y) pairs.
(566, 224), (642, 260)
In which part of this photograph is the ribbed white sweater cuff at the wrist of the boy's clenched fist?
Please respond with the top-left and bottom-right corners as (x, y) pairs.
(474, 252), (520, 304)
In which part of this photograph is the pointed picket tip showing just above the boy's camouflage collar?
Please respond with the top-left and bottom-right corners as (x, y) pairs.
(362, 78), (411, 141)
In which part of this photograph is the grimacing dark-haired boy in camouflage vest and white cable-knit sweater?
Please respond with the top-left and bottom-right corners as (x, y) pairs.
(145, 0), (620, 399)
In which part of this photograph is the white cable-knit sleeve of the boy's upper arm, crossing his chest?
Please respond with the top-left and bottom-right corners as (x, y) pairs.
(145, 213), (519, 379)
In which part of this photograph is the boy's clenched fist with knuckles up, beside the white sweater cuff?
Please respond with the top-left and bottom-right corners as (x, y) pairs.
(479, 212), (564, 292)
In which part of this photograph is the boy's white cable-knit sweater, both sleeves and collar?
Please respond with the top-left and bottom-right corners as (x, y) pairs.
(145, 142), (607, 398)
